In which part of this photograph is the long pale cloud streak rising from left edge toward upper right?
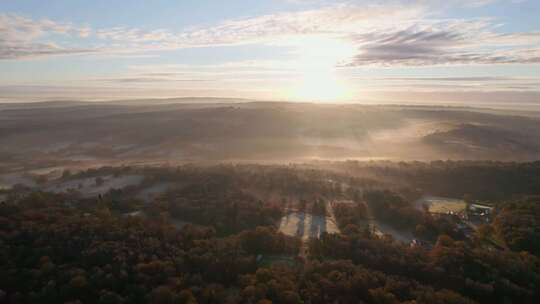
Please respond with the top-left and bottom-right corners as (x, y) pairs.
(0, 5), (428, 59)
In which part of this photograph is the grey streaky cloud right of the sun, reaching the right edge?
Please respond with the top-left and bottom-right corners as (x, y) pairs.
(343, 20), (540, 67)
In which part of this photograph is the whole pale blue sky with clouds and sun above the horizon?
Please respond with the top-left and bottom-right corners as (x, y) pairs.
(0, 0), (540, 108)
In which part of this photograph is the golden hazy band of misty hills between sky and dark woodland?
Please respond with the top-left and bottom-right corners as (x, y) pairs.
(0, 99), (540, 176)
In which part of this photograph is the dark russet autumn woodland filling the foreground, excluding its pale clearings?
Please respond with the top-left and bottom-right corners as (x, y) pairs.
(0, 162), (540, 304)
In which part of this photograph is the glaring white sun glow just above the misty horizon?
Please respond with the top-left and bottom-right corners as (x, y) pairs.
(289, 36), (354, 101)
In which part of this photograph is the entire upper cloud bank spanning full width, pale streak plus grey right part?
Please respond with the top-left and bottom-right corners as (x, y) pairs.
(0, 0), (540, 67)
